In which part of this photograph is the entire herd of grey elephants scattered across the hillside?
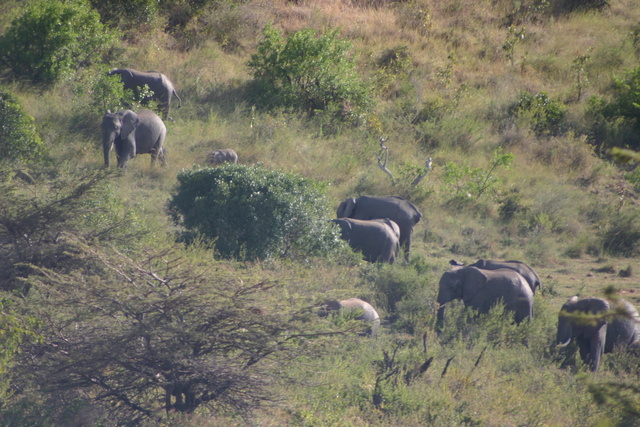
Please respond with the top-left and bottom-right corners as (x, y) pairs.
(102, 68), (640, 371)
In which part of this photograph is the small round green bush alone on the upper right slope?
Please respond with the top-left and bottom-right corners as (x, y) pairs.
(508, 91), (567, 136)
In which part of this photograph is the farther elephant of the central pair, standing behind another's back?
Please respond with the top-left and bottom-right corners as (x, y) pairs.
(337, 196), (422, 261)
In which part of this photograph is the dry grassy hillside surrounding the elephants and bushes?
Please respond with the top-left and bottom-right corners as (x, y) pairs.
(0, 0), (640, 426)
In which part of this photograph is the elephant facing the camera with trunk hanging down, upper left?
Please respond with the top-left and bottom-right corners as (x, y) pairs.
(102, 110), (167, 168)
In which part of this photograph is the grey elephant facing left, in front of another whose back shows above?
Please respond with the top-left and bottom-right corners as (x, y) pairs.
(437, 267), (533, 328)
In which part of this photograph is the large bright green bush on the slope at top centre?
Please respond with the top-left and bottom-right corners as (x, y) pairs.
(247, 26), (373, 121)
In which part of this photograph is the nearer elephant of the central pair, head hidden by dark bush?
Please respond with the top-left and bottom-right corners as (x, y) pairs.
(331, 218), (400, 263)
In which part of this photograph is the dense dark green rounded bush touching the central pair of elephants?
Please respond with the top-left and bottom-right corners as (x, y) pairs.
(169, 165), (342, 260)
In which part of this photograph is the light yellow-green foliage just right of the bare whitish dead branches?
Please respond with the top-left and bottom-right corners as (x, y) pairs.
(442, 148), (515, 200)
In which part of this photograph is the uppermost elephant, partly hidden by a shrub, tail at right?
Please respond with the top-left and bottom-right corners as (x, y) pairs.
(107, 68), (182, 120)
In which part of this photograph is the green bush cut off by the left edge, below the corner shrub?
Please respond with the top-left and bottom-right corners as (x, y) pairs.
(0, 88), (45, 163)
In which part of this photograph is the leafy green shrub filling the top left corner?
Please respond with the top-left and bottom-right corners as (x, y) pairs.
(0, 0), (117, 83)
